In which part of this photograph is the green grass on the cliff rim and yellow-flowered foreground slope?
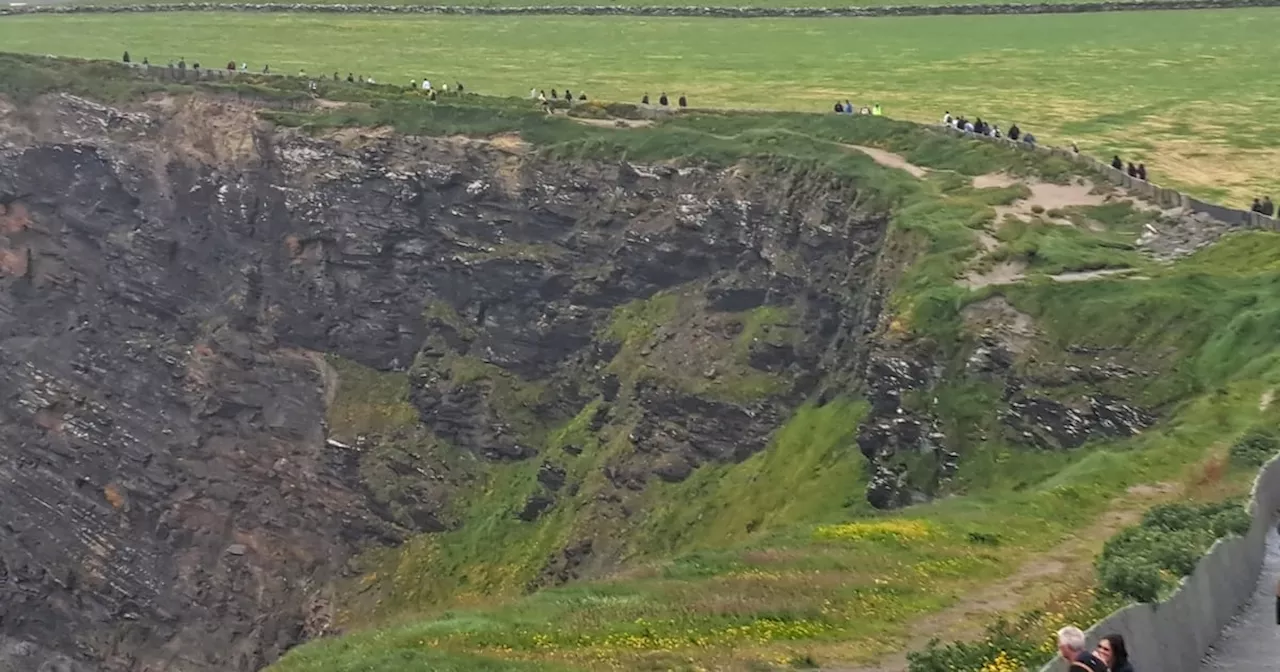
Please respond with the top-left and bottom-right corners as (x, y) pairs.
(10, 59), (1280, 672)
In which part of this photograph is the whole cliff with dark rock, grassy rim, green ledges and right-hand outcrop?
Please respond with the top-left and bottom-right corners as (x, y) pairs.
(0, 57), (1207, 671)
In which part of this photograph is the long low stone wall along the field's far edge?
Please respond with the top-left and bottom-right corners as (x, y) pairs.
(0, 0), (1280, 19)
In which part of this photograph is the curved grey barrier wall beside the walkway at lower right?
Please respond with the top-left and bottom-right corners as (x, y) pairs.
(1041, 450), (1280, 672)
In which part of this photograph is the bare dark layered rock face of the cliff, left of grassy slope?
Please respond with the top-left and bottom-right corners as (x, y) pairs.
(0, 96), (890, 671)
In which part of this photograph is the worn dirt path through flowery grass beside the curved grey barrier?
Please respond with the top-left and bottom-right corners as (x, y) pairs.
(822, 483), (1181, 672)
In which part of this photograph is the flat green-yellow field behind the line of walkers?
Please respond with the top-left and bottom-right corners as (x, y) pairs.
(0, 9), (1280, 206)
